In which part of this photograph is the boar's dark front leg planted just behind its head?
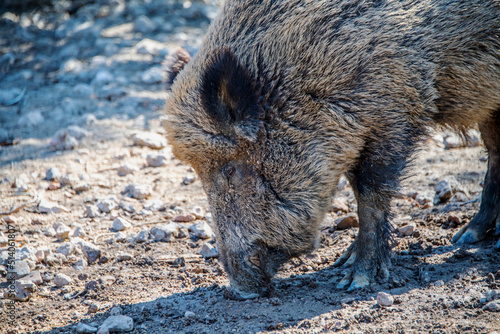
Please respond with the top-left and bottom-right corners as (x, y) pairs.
(334, 134), (417, 291)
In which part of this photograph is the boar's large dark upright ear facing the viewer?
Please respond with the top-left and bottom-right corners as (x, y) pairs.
(201, 49), (262, 141)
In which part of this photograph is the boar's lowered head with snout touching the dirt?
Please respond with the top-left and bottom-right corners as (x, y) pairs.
(164, 49), (335, 299)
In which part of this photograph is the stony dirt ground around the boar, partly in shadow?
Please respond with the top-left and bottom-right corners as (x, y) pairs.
(0, 0), (500, 334)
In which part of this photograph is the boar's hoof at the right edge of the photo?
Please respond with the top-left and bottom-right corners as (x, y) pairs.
(451, 211), (500, 245)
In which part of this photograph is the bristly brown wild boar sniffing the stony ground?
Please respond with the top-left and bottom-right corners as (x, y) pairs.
(165, 0), (500, 299)
